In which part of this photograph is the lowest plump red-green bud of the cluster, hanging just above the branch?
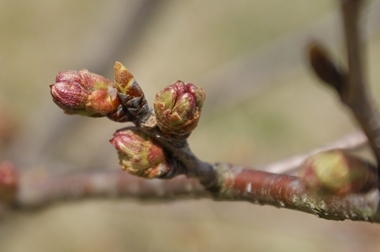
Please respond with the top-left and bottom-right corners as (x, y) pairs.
(110, 128), (171, 178)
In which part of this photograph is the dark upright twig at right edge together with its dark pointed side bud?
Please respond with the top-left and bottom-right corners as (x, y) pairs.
(309, 0), (380, 174)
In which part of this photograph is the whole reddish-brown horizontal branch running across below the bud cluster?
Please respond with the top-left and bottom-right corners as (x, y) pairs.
(6, 163), (380, 223)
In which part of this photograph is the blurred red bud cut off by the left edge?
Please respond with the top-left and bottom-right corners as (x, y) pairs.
(0, 162), (19, 202)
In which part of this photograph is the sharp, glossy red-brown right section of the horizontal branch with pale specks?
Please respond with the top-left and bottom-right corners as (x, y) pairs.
(216, 164), (380, 222)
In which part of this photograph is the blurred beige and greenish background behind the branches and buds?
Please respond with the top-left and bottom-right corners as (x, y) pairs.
(0, 0), (380, 252)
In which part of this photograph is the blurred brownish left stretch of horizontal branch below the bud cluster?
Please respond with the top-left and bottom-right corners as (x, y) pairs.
(15, 171), (209, 210)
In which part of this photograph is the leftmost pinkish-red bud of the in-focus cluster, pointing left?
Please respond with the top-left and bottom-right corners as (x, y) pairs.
(50, 70), (120, 117)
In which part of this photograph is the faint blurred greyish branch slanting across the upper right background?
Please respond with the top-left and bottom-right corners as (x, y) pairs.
(201, 1), (380, 112)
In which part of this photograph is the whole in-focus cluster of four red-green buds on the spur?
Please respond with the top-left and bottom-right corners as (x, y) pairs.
(50, 62), (205, 178)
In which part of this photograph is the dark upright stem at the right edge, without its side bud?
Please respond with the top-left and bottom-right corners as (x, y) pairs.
(340, 0), (380, 169)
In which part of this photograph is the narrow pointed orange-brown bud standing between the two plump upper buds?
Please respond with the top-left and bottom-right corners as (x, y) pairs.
(114, 62), (151, 123)
